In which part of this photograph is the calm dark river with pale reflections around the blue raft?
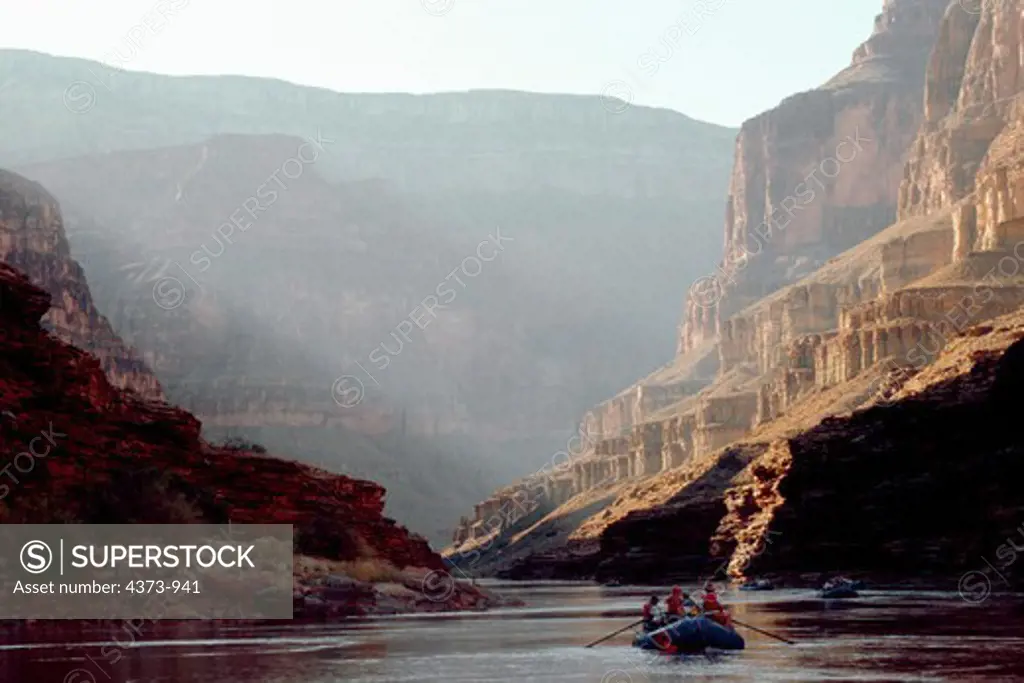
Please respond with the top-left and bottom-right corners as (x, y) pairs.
(0, 582), (1024, 683)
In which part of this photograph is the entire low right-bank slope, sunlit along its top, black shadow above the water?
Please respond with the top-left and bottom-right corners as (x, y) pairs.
(499, 311), (1024, 589)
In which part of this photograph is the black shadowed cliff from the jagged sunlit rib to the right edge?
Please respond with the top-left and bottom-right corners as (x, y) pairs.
(711, 311), (1024, 585)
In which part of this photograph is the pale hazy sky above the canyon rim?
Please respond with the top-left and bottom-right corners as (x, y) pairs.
(0, 0), (882, 125)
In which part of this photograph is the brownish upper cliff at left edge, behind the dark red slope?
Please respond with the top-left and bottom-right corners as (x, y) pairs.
(0, 170), (162, 398)
